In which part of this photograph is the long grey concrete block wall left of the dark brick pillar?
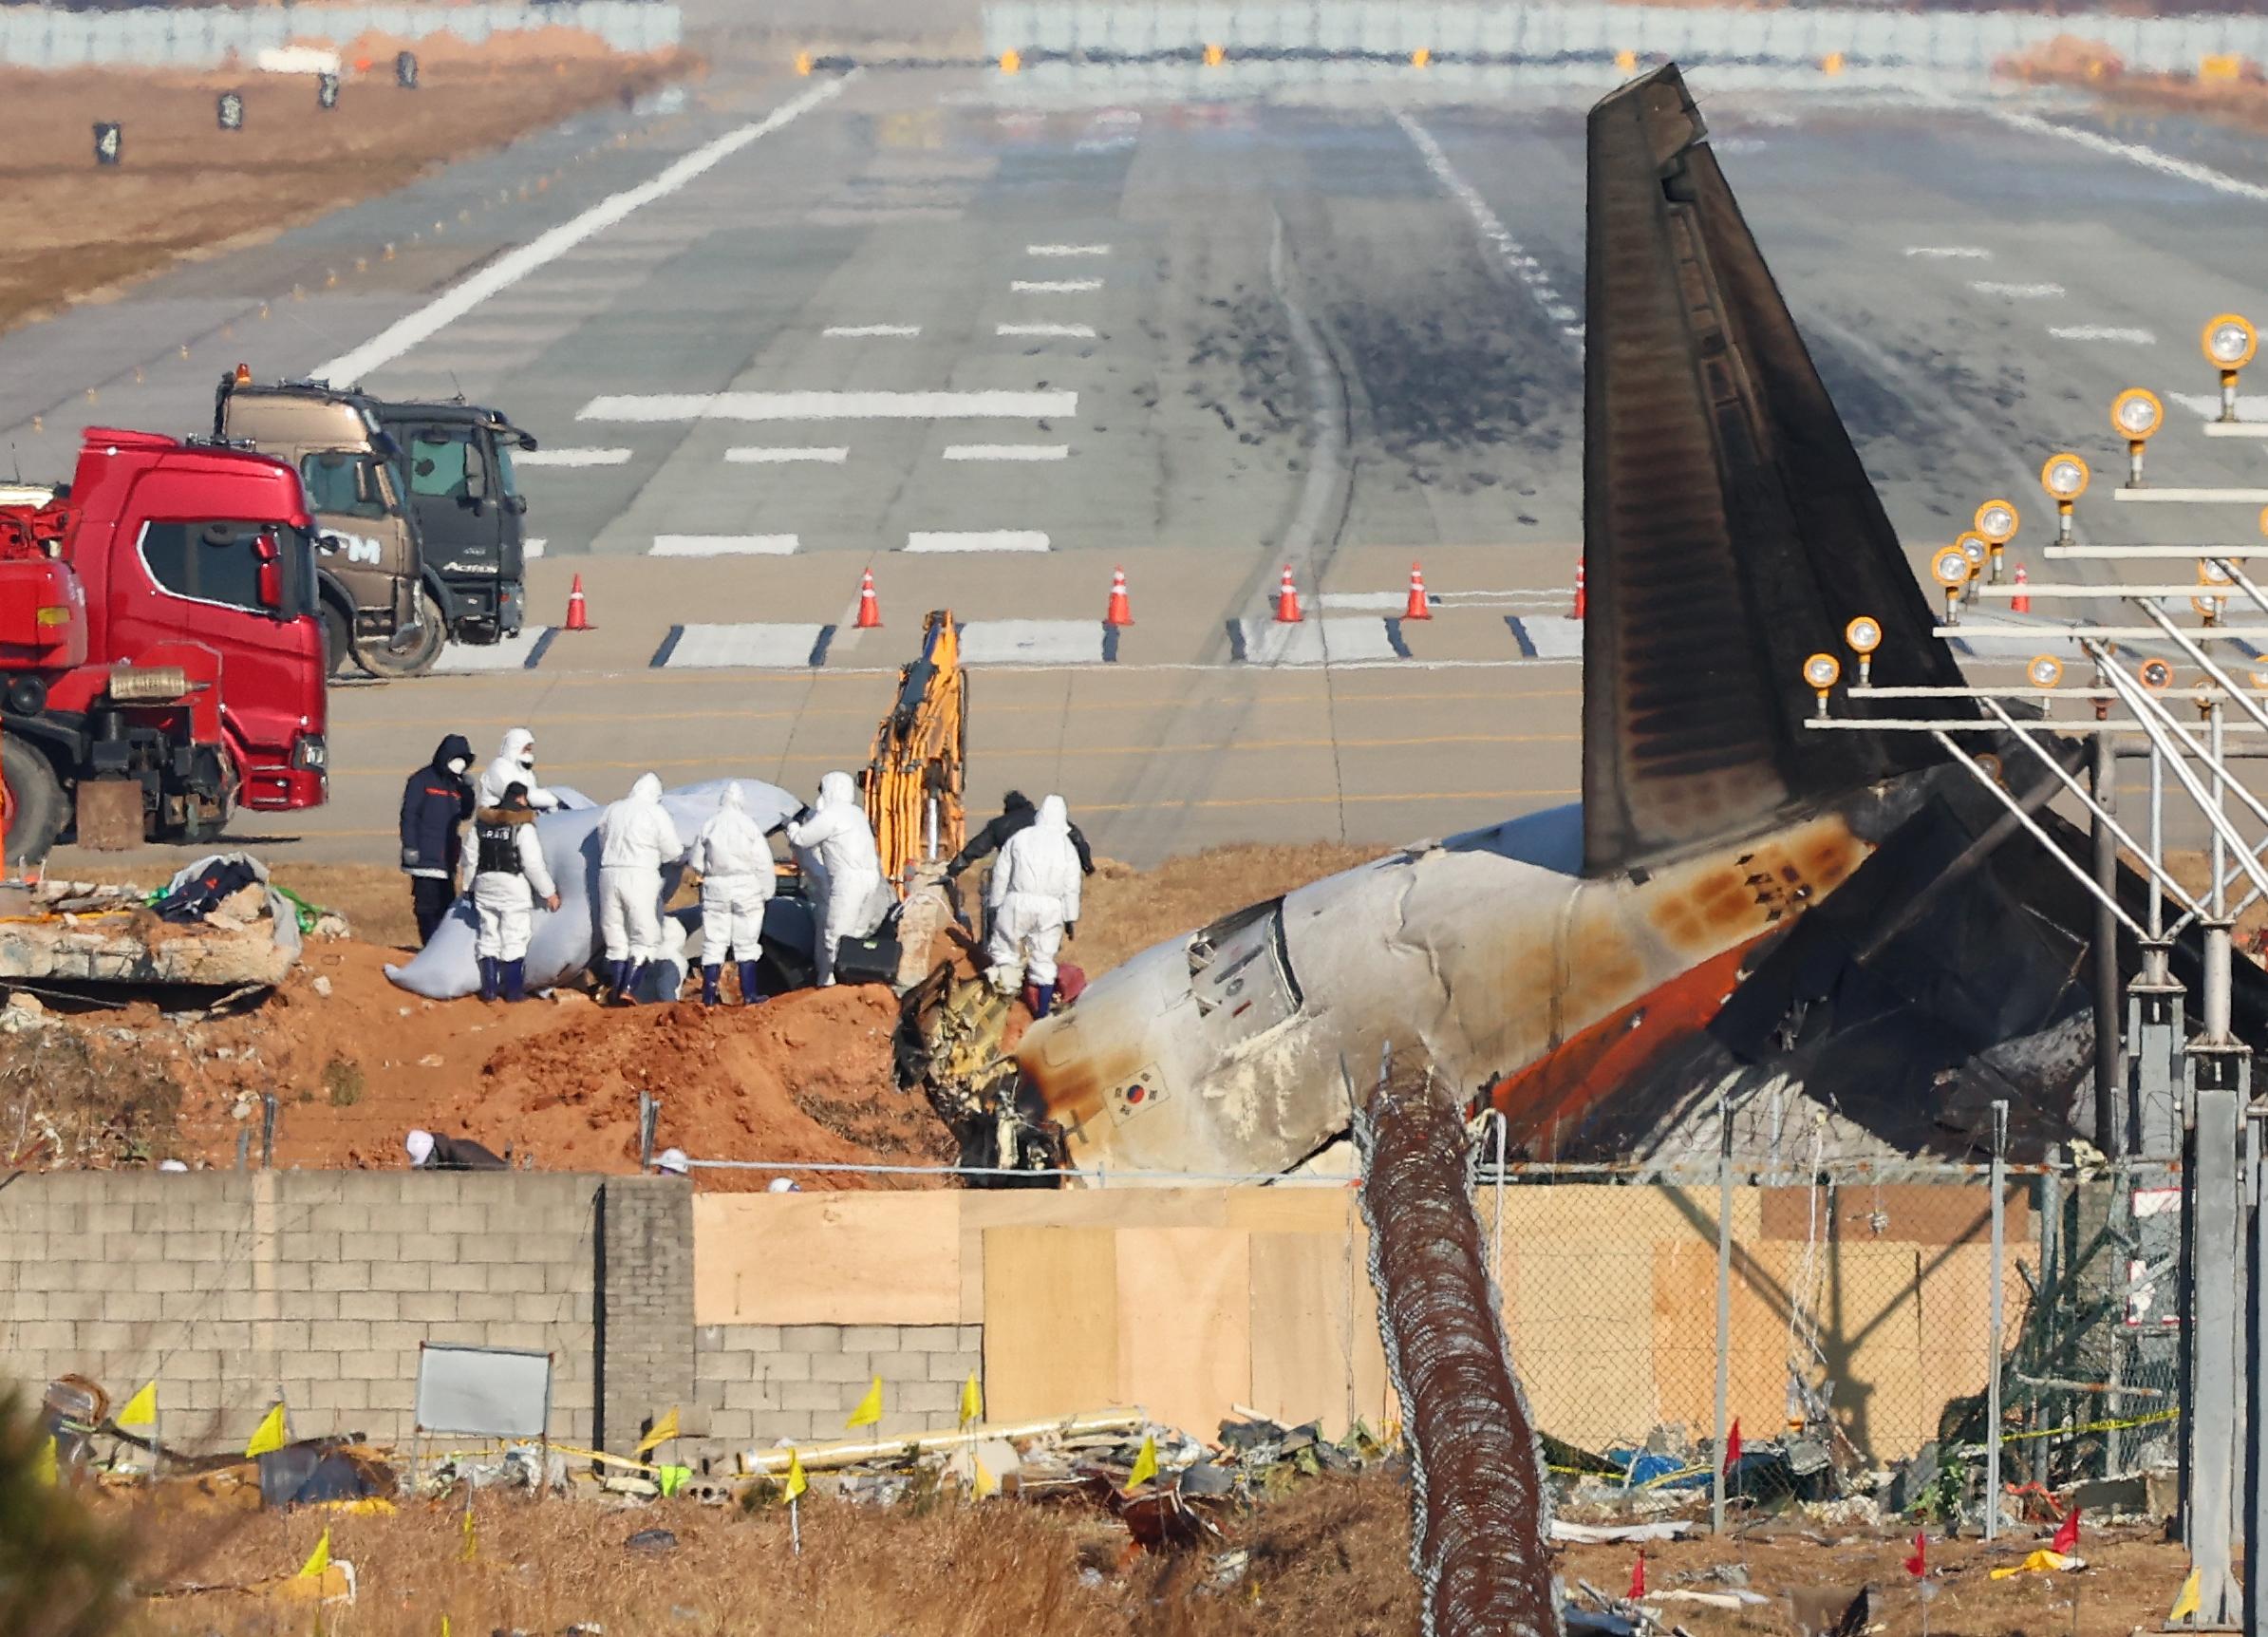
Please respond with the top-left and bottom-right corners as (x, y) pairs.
(0, 1172), (603, 1449)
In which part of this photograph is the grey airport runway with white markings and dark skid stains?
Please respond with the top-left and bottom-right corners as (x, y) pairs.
(17, 55), (2268, 864)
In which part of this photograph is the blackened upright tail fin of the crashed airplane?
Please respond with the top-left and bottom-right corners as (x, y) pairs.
(1584, 68), (1959, 875)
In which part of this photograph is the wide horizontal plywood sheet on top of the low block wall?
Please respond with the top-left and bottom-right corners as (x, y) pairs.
(694, 1191), (962, 1324)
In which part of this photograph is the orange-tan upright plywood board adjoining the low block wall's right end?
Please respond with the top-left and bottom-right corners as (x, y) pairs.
(984, 1227), (1127, 1421)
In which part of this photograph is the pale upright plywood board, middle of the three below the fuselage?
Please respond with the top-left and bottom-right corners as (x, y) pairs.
(1120, 1229), (1252, 1438)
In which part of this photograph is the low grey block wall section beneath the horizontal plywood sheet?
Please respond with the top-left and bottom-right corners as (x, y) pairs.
(681, 1324), (984, 1460)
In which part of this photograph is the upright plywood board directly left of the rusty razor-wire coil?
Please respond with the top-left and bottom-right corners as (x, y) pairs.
(1246, 1233), (1399, 1438)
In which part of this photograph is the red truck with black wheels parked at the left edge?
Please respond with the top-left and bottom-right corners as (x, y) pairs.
(0, 426), (327, 864)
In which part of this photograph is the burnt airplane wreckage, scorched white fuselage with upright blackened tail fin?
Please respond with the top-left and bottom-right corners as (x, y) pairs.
(916, 68), (2268, 1172)
